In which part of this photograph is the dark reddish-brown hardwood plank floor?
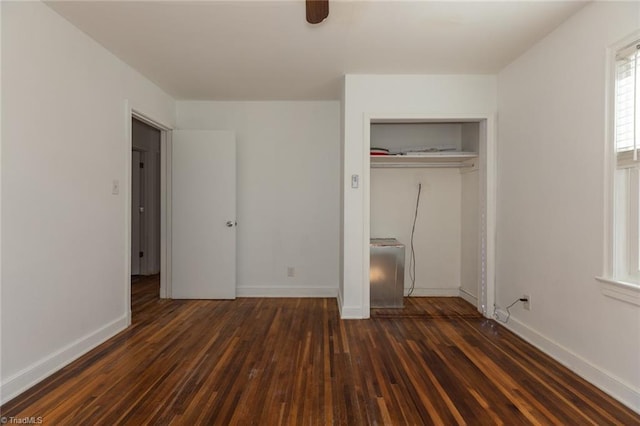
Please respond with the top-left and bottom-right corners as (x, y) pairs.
(2, 277), (640, 425)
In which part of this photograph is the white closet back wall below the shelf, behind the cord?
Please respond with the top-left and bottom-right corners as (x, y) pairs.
(370, 168), (461, 296)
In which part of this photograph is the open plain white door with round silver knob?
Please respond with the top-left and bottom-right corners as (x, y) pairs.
(171, 130), (236, 299)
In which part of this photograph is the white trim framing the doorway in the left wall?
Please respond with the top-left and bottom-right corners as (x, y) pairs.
(121, 100), (173, 325)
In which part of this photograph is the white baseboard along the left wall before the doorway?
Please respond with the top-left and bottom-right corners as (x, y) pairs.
(0, 315), (127, 404)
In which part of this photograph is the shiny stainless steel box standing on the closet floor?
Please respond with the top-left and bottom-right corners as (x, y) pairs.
(369, 238), (404, 308)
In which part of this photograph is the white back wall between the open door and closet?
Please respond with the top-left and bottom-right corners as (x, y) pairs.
(177, 102), (340, 296)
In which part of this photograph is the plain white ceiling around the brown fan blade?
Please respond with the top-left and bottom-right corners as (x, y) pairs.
(48, 0), (585, 100)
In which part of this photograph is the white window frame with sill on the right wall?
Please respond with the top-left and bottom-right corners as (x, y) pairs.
(596, 30), (640, 306)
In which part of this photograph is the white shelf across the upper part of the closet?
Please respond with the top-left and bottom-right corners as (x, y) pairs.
(371, 152), (478, 168)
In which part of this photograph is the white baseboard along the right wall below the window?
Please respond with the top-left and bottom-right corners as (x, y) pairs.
(496, 309), (640, 413)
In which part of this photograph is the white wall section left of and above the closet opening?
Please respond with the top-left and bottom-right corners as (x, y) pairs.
(339, 75), (497, 318)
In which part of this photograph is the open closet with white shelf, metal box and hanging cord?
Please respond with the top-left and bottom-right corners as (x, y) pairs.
(364, 116), (493, 316)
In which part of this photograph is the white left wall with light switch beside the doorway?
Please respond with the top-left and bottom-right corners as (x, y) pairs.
(0, 2), (174, 401)
